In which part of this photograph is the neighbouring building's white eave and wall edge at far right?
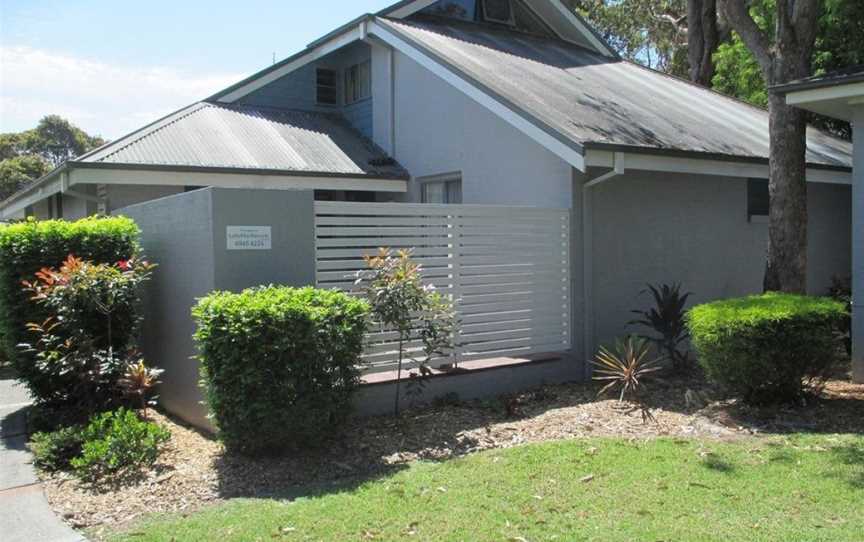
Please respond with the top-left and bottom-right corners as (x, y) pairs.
(772, 66), (864, 382)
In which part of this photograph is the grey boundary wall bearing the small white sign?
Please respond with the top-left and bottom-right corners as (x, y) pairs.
(117, 188), (315, 427)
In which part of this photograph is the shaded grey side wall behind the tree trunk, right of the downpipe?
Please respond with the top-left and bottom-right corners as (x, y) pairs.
(588, 172), (851, 352)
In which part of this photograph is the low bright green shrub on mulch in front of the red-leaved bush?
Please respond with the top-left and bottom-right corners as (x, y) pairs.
(70, 408), (171, 482)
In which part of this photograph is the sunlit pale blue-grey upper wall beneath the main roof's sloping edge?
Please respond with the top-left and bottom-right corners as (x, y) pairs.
(384, 48), (572, 208)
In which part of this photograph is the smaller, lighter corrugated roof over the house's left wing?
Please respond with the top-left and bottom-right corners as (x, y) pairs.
(78, 102), (407, 178)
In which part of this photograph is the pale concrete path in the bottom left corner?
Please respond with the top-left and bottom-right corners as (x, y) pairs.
(0, 380), (85, 542)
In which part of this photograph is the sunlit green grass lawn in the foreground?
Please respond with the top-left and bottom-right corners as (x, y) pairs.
(109, 435), (864, 542)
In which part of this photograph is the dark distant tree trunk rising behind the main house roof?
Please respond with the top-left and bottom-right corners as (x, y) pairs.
(687, 0), (720, 87)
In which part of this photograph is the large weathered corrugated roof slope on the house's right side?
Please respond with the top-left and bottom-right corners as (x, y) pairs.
(379, 18), (852, 167)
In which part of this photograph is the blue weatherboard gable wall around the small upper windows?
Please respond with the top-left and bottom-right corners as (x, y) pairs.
(239, 43), (373, 139)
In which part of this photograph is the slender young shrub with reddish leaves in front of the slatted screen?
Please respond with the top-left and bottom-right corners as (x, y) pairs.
(357, 248), (458, 416)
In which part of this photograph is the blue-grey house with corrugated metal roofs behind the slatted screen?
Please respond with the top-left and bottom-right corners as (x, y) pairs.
(0, 0), (852, 422)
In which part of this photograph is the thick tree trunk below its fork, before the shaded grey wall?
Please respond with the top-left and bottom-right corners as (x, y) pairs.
(763, 90), (807, 293)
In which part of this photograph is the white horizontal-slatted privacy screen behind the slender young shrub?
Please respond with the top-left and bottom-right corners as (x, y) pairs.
(315, 202), (571, 372)
